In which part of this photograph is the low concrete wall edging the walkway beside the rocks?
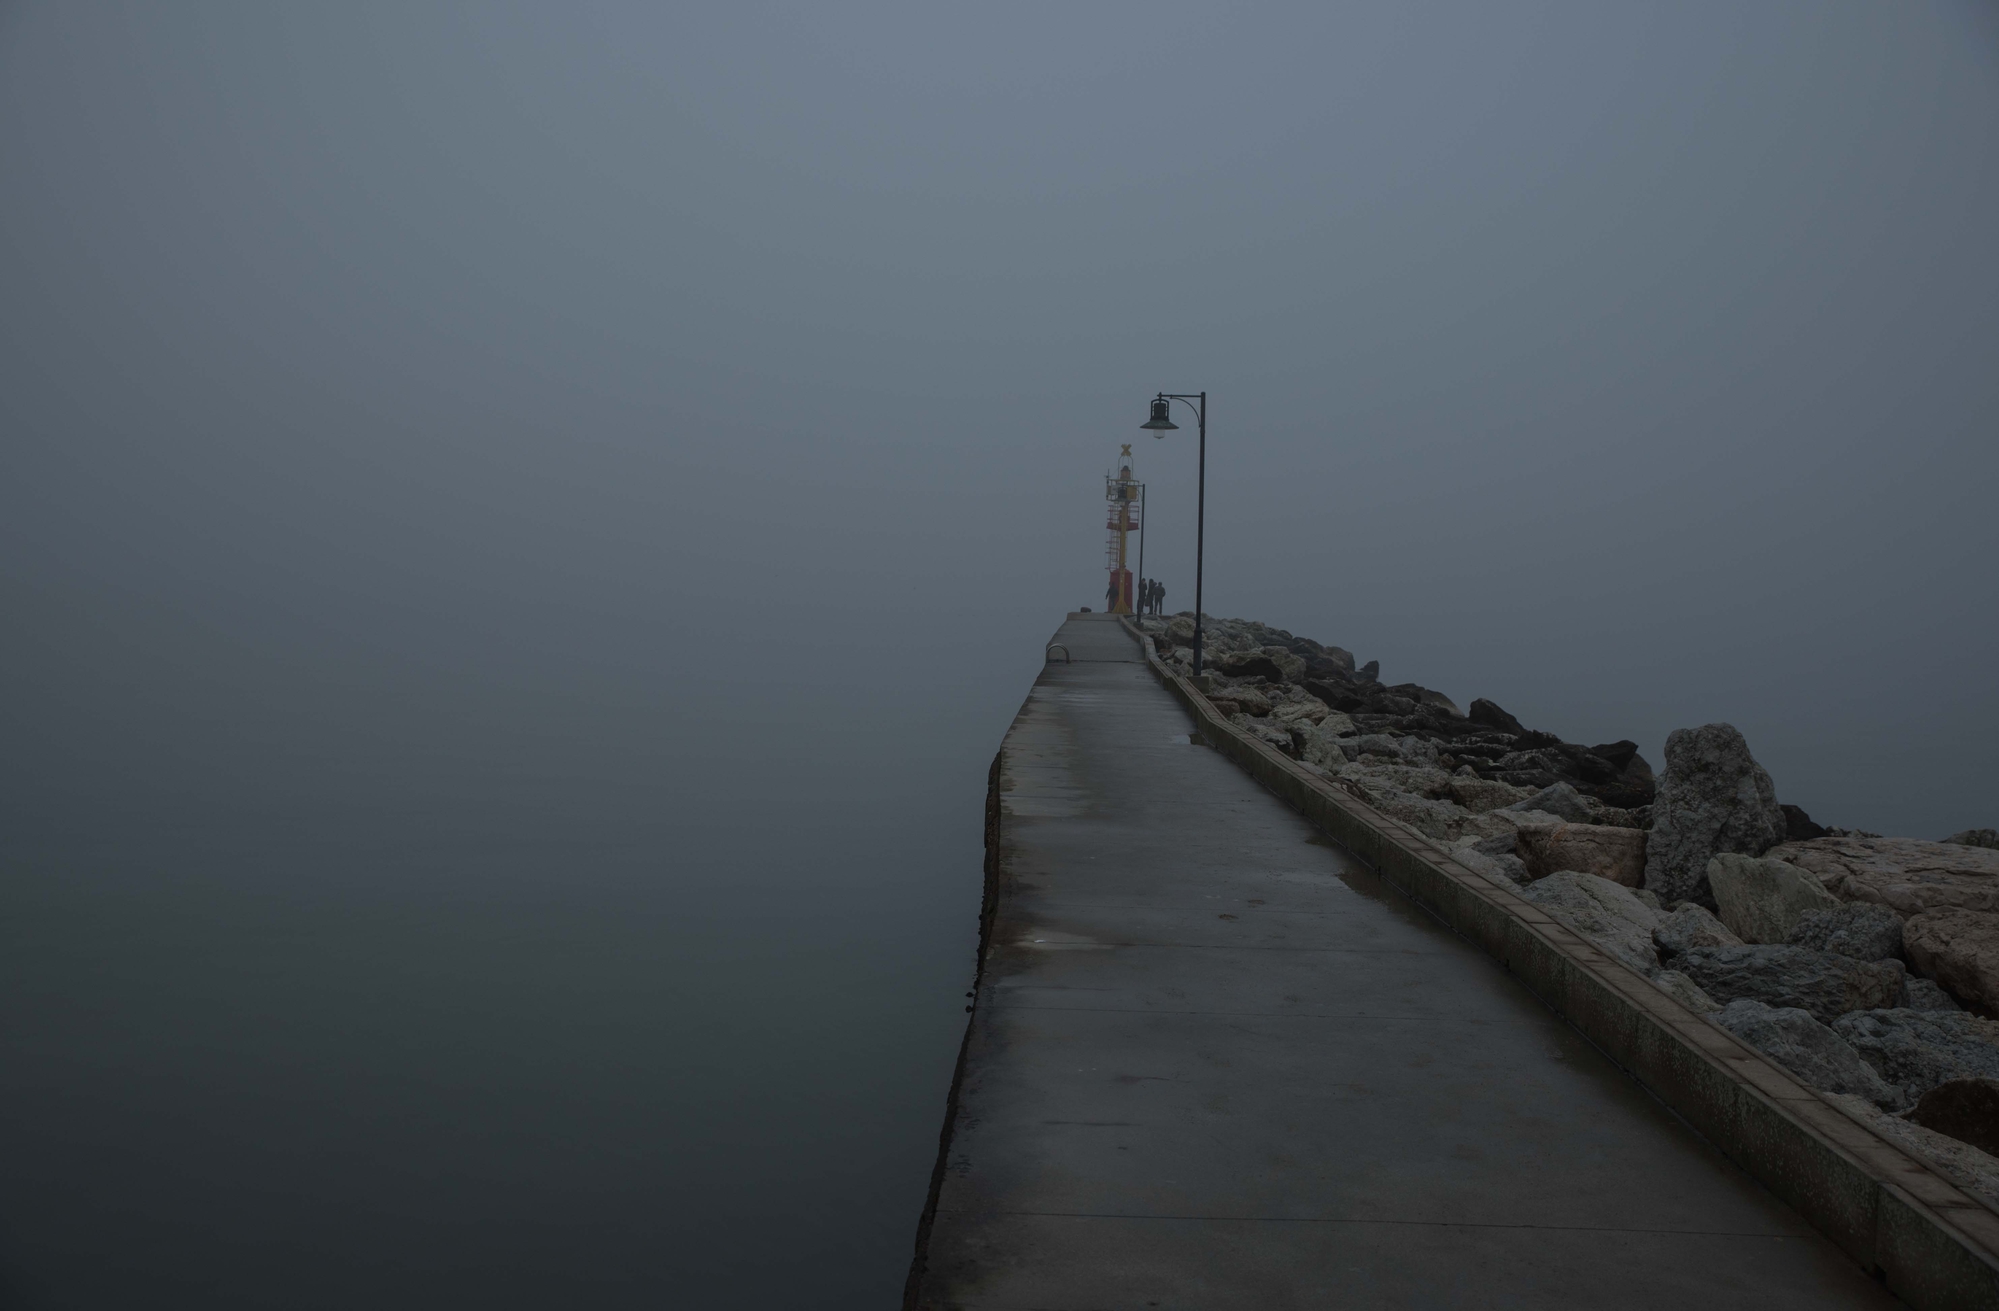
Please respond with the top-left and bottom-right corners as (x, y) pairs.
(1125, 624), (1999, 1311)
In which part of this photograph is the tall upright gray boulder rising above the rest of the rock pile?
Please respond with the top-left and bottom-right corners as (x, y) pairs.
(1645, 723), (1783, 905)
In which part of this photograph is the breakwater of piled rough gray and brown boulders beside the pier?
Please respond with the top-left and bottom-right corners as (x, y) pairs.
(1139, 614), (1999, 1207)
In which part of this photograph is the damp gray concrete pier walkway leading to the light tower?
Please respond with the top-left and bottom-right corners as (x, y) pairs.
(910, 616), (1897, 1311)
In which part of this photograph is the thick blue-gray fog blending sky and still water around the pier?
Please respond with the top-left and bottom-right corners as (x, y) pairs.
(0, 0), (1999, 1307)
